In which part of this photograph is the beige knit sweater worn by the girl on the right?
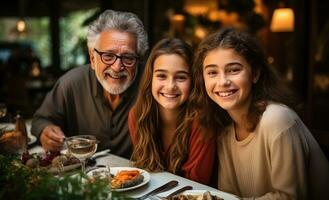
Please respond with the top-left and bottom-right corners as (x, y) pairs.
(218, 104), (329, 199)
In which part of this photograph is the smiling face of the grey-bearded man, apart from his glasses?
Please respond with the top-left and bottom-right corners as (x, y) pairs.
(89, 29), (137, 94)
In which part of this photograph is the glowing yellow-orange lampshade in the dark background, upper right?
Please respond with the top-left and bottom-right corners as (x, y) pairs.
(270, 8), (295, 32)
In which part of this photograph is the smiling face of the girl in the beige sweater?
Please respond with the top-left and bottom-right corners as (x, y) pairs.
(203, 48), (258, 115)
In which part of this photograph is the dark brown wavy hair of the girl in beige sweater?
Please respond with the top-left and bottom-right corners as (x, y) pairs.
(191, 28), (296, 132)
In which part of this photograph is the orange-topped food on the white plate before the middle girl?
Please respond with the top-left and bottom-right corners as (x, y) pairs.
(111, 170), (144, 189)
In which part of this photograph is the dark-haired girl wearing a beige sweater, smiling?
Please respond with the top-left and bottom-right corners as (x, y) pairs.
(191, 29), (329, 199)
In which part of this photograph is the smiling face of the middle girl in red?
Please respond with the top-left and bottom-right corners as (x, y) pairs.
(152, 54), (191, 110)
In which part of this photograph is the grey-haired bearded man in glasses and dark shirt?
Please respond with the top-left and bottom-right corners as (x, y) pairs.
(32, 10), (148, 157)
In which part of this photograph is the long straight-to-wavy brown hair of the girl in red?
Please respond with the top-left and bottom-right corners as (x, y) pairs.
(132, 38), (194, 174)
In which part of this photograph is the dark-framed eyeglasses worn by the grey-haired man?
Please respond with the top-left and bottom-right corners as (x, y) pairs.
(94, 49), (138, 68)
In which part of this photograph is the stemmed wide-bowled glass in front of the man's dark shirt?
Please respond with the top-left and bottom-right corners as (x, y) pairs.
(65, 135), (98, 172)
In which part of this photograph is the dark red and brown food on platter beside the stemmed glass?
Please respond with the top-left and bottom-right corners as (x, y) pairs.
(22, 151), (80, 168)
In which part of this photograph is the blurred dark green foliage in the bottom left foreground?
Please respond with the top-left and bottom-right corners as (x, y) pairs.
(0, 154), (127, 200)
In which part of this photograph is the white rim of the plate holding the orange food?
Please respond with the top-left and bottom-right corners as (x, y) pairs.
(87, 167), (151, 192)
